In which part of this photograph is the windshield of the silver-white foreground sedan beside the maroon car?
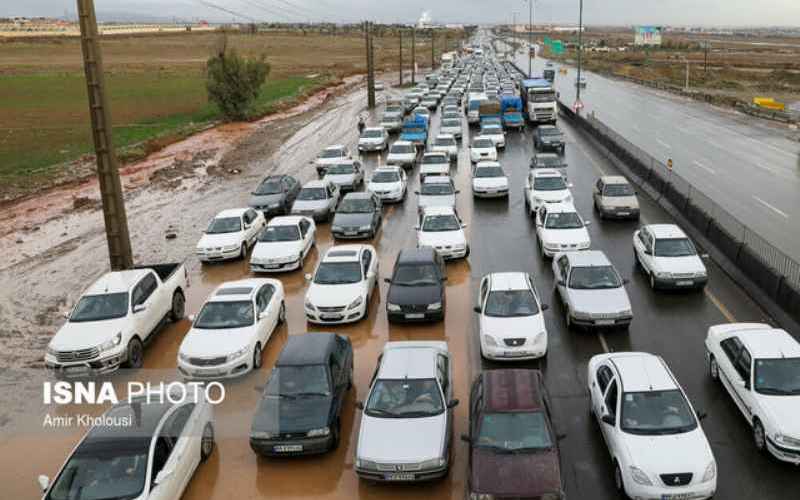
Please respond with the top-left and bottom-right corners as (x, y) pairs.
(365, 379), (444, 418)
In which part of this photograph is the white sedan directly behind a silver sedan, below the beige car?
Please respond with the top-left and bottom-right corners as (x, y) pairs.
(536, 203), (592, 258)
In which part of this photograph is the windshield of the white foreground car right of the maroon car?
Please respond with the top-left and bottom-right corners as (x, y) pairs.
(620, 389), (697, 435)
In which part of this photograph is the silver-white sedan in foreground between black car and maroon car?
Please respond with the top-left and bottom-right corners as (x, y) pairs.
(355, 341), (458, 482)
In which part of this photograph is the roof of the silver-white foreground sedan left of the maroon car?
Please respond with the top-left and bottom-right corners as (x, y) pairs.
(378, 341), (447, 379)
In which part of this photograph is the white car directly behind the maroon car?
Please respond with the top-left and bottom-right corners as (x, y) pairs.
(475, 273), (548, 360)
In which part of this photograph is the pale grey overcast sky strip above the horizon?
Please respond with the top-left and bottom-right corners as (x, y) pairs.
(0, 0), (800, 26)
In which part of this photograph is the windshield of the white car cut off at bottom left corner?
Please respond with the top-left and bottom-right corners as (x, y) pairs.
(45, 438), (149, 500)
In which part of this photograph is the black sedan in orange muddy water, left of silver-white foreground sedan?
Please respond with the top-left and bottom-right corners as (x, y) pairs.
(250, 333), (353, 456)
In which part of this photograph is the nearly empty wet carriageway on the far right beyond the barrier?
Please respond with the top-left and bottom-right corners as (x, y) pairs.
(515, 42), (800, 260)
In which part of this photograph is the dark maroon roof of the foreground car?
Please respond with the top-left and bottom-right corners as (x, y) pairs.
(482, 369), (544, 411)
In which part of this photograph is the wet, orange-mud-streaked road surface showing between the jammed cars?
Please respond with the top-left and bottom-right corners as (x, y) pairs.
(10, 80), (800, 500)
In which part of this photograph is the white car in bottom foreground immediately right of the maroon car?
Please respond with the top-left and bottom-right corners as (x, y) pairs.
(586, 352), (717, 500)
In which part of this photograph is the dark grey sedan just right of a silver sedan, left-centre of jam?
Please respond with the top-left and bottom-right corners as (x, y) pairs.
(331, 192), (383, 239)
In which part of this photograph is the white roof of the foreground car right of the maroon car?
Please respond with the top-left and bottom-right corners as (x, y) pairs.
(608, 352), (678, 392)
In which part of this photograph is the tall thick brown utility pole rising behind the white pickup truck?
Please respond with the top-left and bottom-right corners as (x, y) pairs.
(77, 0), (133, 271)
